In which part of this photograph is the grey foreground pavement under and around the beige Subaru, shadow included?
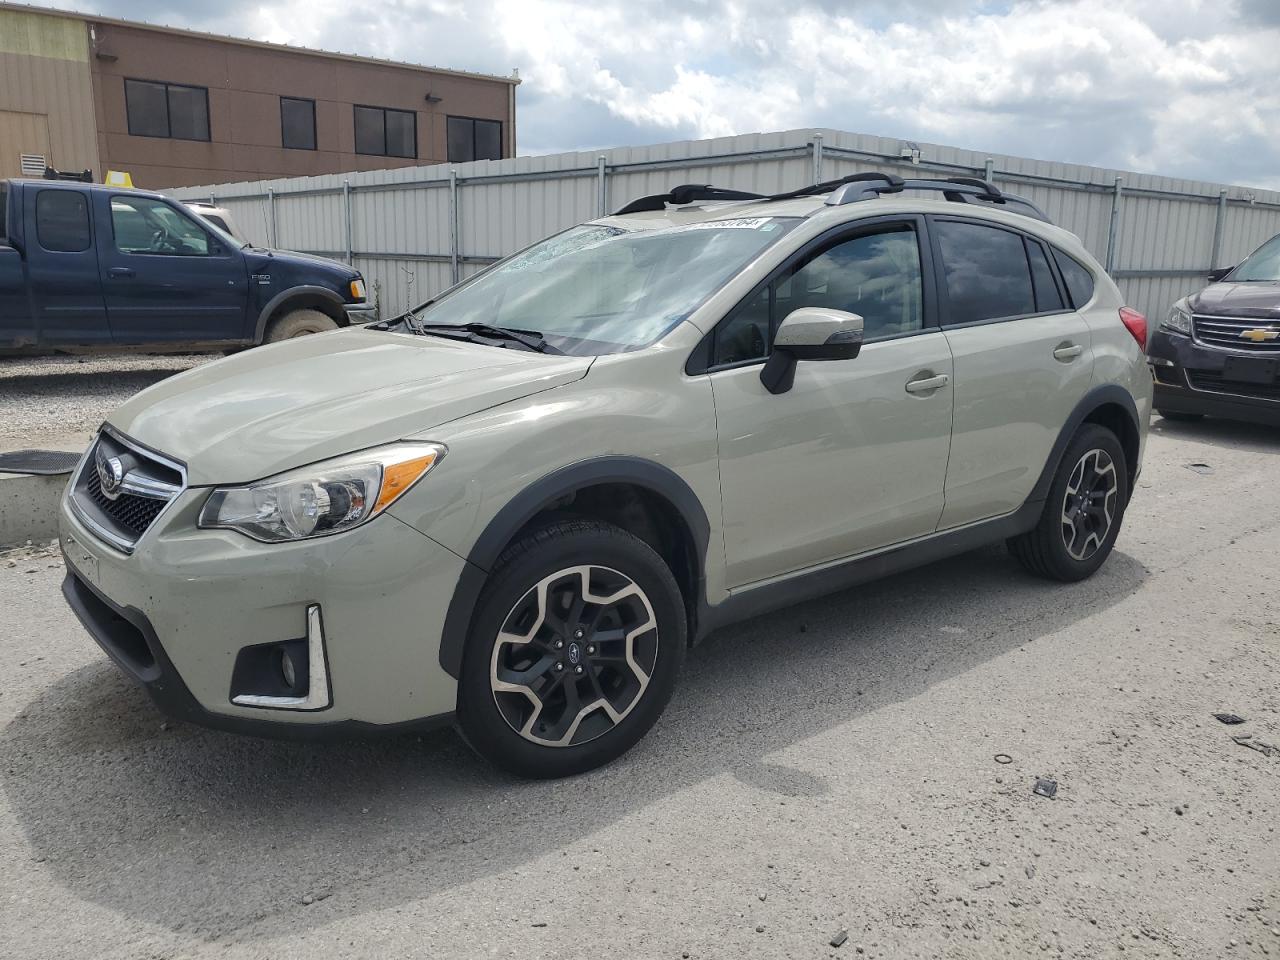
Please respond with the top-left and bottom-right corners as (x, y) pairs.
(0, 421), (1280, 960)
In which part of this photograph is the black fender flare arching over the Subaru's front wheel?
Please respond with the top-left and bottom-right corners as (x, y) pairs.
(440, 456), (710, 678)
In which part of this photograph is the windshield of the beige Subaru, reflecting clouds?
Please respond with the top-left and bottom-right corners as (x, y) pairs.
(404, 216), (799, 356)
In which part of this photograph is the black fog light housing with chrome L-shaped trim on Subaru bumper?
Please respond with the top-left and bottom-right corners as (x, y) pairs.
(230, 604), (333, 710)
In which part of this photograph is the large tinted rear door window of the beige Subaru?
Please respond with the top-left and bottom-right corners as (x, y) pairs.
(931, 220), (1036, 326)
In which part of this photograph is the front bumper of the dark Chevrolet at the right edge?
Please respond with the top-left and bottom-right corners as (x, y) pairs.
(1147, 330), (1280, 426)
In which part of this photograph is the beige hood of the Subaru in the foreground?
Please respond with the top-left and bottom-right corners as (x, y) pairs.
(109, 329), (591, 486)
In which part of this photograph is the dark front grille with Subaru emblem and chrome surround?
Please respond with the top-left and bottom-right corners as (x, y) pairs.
(70, 430), (186, 553)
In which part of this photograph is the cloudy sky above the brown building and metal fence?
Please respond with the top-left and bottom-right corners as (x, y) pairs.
(35, 0), (1280, 188)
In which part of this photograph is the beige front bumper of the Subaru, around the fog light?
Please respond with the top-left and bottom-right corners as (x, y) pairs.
(59, 489), (465, 736)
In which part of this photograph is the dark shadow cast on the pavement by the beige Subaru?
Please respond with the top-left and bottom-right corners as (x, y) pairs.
(0, 548), (1147, 940)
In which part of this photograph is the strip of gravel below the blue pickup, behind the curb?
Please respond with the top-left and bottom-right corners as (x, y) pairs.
(0, 353), (209, 449)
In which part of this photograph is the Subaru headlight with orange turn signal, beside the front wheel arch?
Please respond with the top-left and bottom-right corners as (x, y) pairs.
(200, 443), (445, 543)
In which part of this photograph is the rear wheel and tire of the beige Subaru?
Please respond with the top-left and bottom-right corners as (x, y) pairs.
(1009, 424), (1129, 582)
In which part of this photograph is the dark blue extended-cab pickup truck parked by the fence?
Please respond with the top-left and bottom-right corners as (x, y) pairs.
(0, 179), (376, 355)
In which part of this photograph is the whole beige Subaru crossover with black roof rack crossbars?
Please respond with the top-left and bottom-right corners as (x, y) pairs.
(61, 174), (1152, 777)
